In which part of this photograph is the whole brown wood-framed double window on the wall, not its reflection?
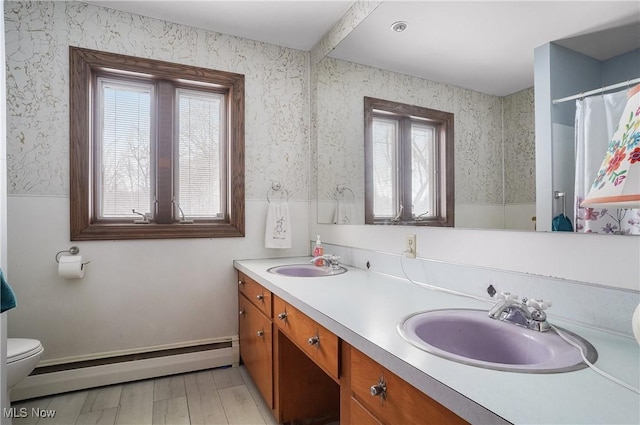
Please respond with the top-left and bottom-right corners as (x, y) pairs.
(70, 47), (244, 240)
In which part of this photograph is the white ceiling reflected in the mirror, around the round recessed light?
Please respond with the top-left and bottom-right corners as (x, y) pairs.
(330, 1), (640, 95)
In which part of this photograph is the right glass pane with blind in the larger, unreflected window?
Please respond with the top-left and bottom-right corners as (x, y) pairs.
(176, 89), (226, 219)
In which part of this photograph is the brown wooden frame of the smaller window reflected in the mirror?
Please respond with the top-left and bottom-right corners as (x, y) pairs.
(364, 96), (455, 227)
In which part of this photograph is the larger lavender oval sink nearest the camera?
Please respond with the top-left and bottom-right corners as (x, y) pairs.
(398, 309), (598, 373)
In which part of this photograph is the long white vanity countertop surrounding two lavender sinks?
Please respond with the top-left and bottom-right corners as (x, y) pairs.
(234, 257), (640, 424)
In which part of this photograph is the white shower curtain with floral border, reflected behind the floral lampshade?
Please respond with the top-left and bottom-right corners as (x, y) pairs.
(575, 90), (640, 235)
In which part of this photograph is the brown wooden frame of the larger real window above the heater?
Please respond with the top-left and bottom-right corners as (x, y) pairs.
(69, 46), (245, 241)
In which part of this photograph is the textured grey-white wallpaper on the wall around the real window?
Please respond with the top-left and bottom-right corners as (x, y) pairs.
(5, 2), (309, 200)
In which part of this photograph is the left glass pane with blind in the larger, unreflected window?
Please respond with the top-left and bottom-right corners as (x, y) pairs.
(96, 78), (153, 218)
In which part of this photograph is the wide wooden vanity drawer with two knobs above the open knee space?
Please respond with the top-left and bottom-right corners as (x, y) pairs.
(273, 296), (339, 381)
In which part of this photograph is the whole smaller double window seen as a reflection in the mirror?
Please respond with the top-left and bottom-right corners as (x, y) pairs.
(364, 97), (454, 226)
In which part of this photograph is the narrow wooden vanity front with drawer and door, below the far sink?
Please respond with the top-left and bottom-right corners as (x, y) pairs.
(238, 272), (273, 409)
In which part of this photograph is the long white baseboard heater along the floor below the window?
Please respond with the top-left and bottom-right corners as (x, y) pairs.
(10, 337), (239, 402)
